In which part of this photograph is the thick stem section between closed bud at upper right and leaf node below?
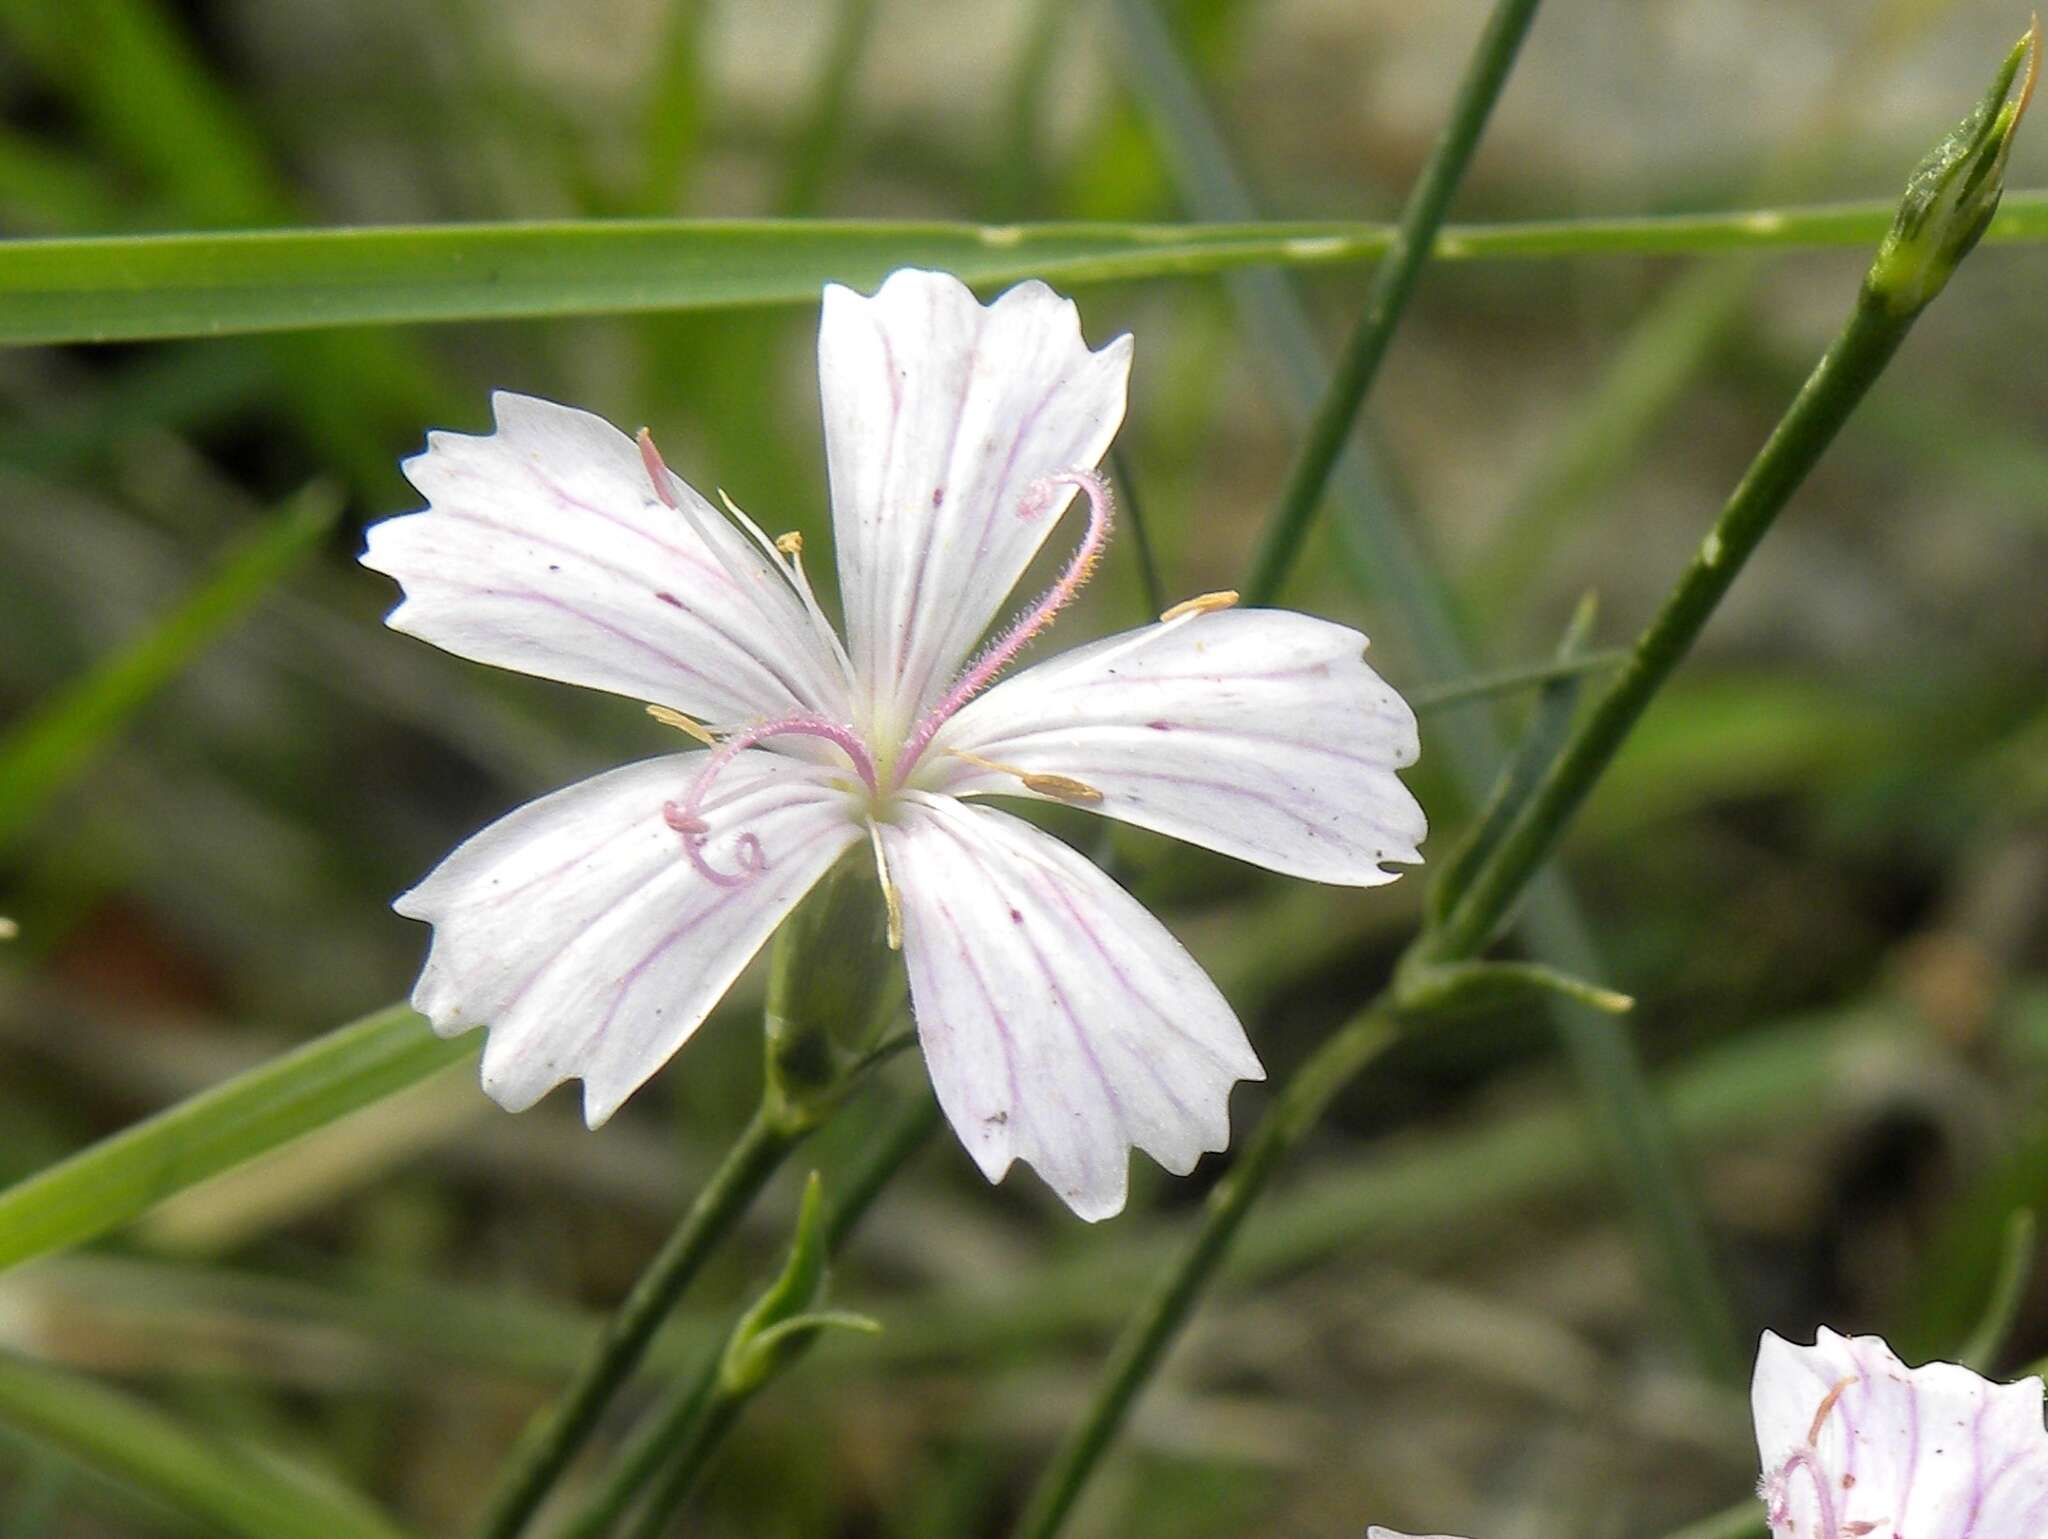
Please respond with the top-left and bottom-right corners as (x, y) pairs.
(1425, 285), (1919, 961)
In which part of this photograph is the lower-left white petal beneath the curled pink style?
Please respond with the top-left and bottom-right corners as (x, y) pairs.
(393, 752), (862, 1127)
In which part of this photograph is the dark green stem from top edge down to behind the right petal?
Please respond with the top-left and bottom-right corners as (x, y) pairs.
(1245, 0), (1538, 605)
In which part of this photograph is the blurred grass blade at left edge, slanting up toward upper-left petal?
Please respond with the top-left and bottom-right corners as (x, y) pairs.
(0, 486), (342, 848)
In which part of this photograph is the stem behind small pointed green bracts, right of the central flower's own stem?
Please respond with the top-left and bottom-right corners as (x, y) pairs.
(557, 1094), (938, 1539)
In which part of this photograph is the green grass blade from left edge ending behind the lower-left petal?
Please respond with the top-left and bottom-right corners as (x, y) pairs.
(0, 1004), (477, 1268)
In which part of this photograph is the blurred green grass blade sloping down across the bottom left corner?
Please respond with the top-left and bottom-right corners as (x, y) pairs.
(0, 1353), (415, 1539)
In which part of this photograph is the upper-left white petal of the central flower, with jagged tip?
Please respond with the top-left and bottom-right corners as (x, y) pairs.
(362, 391), (846, 723)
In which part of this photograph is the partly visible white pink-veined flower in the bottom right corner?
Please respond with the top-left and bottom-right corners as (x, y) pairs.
(1751, 1328), (2048, 1539)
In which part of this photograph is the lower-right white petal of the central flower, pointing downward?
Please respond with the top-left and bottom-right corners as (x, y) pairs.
(883, 791), (1266, 1219)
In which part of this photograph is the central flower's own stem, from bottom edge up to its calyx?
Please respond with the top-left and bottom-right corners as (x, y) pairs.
(477, 1103), (809, 1539)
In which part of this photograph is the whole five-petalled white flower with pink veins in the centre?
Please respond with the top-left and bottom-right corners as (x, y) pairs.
(362, 271), (1423, 1219)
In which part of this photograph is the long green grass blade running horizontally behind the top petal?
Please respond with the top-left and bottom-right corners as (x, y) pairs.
(0, 193), (2048, 344)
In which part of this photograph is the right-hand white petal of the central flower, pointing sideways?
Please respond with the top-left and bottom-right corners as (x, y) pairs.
(918, 609), (1427, 887)
